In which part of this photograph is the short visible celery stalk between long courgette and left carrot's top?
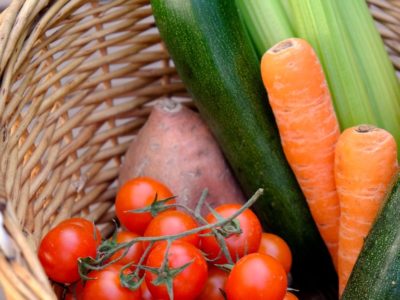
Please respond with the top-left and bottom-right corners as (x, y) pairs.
(236, 0), (294, 57)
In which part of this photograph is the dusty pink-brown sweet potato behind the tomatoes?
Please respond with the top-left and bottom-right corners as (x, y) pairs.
(119, 100), (245, 212)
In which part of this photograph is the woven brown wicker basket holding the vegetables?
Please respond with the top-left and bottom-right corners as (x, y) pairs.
(0, 0), (400, 299)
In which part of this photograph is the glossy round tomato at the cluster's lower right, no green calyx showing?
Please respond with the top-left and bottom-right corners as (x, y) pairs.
(225, 253), (287, 300)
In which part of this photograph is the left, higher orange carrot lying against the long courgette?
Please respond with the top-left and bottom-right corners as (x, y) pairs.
(261, 38), (340, 266)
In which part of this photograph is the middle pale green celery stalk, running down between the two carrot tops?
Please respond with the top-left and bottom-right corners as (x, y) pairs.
(291, 0), (376, 129)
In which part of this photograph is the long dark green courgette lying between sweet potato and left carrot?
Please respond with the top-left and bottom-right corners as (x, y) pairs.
(151, 0), (337, 288)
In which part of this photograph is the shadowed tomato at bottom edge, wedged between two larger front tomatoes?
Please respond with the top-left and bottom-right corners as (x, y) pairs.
(196, 267), (228, 300)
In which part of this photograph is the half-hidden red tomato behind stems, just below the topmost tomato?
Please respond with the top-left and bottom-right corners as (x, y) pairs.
(110, 231), (144, 265)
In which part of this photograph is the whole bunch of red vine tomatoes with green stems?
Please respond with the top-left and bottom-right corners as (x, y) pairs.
(38, 177), (296, 300)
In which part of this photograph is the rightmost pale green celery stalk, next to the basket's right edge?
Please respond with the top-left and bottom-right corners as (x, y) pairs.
(337, 0), (400, 145)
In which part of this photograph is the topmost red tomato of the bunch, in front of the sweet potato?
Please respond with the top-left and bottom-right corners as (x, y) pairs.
(115, 177), (175, 235)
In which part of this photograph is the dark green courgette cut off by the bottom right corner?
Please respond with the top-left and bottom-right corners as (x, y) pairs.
(342, 177), (400, 300)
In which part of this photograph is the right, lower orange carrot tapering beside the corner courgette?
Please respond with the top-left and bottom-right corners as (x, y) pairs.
(335, 125), (398, 294)
